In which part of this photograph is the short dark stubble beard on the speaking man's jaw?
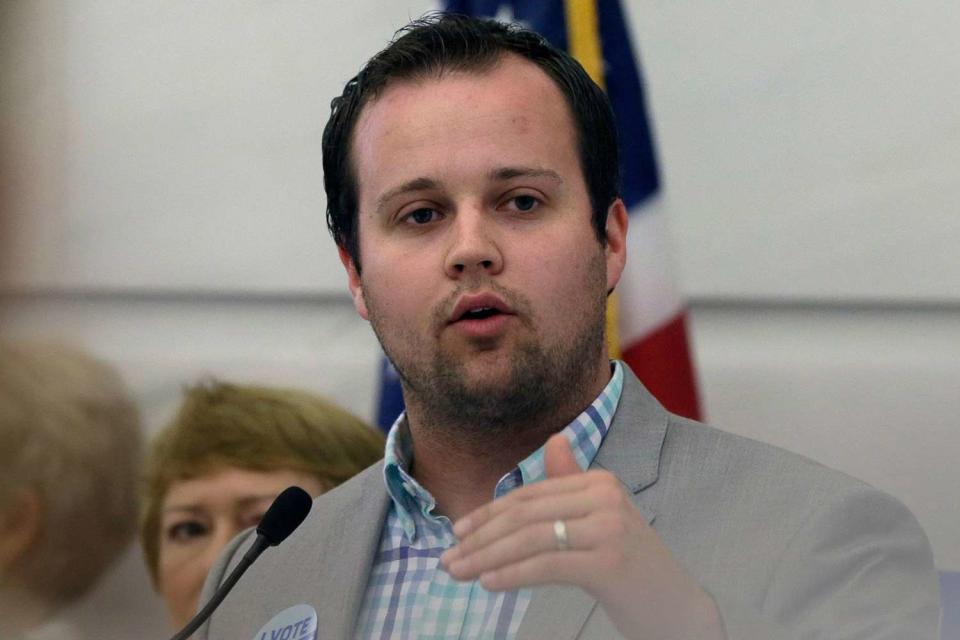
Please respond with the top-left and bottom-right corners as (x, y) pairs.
(365, 254), (606, 438)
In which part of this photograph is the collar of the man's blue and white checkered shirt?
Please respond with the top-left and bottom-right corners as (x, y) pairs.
(383, 360), (623, 540)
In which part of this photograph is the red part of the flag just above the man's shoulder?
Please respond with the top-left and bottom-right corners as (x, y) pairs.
(623, 311), (701, 420)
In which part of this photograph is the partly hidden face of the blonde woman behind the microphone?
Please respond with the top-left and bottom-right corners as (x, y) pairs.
(157, 467), (324, 628)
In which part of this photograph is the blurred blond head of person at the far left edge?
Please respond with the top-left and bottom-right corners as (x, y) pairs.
(0, 340), (141, 637)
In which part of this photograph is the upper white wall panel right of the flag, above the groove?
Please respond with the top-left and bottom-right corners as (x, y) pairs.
(630, 0), (960, 303)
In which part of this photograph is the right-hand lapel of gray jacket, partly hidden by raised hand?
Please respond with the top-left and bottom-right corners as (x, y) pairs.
(517, 365), (667, 640)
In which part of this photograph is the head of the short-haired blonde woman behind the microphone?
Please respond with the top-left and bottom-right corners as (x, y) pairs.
(140, 382), (384, 627)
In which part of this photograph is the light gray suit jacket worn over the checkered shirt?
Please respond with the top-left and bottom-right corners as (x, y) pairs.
(196, 369), (939, 640)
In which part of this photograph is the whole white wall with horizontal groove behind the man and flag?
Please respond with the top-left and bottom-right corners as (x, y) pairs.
(0, 0), (960, 638)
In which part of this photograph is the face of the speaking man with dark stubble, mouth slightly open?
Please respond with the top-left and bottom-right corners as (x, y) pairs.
(341, 56), (626, 420)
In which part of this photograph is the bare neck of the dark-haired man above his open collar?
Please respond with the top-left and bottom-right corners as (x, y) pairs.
(407, 358), (610, 522)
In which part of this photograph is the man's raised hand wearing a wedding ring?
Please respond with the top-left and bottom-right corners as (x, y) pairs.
(441, 434), (723, 640)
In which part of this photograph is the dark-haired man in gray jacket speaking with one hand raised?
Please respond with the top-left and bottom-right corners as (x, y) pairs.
(200, 17), (938, 639)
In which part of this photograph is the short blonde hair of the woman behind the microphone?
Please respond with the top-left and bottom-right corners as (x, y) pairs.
(140, 381), (384, 584)
